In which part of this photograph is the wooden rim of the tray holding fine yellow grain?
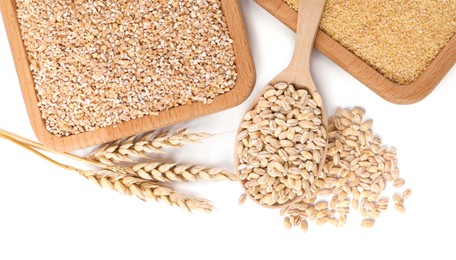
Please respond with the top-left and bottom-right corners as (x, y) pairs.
(254, 0), (456, 104)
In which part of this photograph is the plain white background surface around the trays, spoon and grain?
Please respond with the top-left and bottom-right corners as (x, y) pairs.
(0, 1), (456, 260)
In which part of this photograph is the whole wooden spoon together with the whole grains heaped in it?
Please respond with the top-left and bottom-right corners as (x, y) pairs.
(235, 0), (327, 208)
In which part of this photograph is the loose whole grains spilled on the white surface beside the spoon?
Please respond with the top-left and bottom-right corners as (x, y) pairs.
(281, 108), (411, 232)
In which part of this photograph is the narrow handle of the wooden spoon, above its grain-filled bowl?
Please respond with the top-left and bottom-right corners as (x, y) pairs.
(289, 0), (326, 74)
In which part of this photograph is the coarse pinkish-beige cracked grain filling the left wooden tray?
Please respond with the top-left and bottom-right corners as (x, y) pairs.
(16, 0), (237, 136)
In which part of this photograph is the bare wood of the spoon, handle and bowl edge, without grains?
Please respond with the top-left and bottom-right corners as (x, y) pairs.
(235, 0), (327, 208)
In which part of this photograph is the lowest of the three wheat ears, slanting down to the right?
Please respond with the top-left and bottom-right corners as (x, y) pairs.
(78, 170), (213, 212)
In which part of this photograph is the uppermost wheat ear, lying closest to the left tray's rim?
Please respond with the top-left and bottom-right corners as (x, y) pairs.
(88, 128), (211, 165)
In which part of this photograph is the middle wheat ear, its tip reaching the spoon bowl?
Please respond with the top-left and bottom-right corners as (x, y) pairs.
(125, 162), (238, 182)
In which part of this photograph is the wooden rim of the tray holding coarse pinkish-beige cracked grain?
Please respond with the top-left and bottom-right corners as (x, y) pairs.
(0, 0), (256, 151)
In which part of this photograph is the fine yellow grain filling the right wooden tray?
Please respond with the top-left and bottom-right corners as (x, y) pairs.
(283, 0), (456, 84)
